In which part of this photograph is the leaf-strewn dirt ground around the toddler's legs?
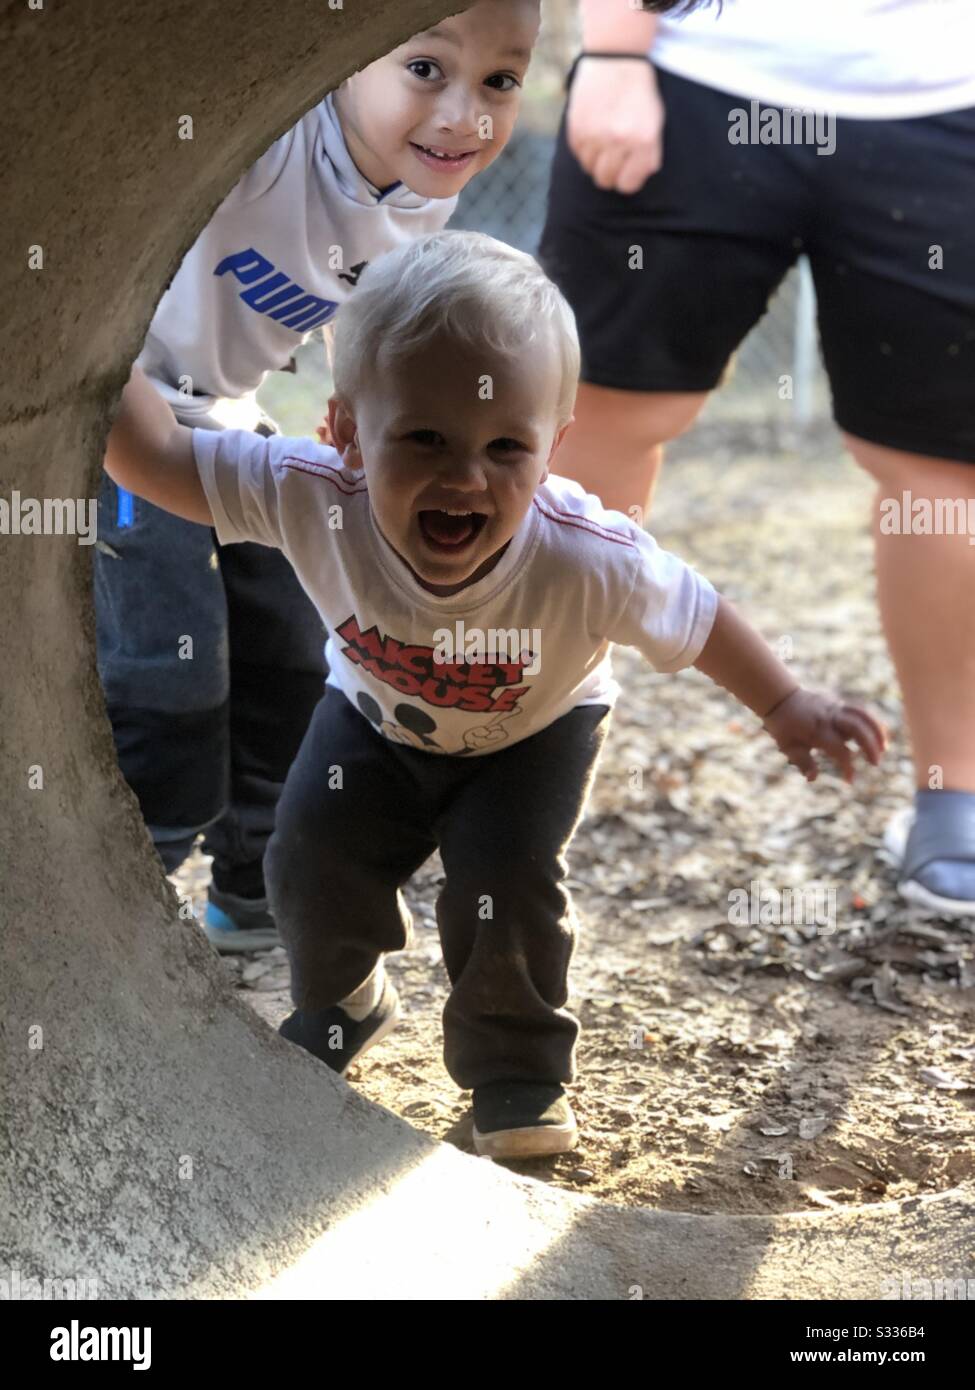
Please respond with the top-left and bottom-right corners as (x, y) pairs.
(172, 431), (975, 1213)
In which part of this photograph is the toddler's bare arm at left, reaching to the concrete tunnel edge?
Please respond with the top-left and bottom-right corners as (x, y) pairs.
(104, 367), (213, 525)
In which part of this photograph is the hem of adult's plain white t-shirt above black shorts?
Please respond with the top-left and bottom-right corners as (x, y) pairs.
(651, 0), (975, 120)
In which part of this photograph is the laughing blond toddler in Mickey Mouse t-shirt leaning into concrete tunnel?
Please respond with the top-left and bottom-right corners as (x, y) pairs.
(106, 232), (883, 1156)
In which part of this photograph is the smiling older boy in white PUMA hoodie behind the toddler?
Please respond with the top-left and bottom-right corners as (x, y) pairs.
(95, 0), (538, 951)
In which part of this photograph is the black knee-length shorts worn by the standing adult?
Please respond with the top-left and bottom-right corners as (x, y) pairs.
(538, 71), (975, 463)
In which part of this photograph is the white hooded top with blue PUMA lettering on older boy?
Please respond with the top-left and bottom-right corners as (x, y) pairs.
(138, 93), (458, 425)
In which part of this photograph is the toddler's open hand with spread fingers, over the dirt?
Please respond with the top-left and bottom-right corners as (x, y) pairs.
(762, 688), (887, 783)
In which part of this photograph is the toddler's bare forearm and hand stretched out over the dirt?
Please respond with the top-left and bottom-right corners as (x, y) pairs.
(694, 596), (887, 781)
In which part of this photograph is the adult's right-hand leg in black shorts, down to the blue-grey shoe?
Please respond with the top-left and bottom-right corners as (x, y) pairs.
(809, 107), (975, 915)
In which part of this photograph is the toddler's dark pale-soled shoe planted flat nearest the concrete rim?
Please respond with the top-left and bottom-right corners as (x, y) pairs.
(473, 1081), (579, 1158)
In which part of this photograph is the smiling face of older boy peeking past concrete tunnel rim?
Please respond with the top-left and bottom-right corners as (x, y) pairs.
(335, 0), (540, 197)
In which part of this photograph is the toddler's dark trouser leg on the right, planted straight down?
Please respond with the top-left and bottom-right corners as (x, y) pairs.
(437, 705), (608, 1090)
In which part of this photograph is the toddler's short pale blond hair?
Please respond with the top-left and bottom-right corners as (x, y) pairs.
(330, 231), (580, 427)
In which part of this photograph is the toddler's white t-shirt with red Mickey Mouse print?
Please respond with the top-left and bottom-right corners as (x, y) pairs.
(193, 430), (718, 755)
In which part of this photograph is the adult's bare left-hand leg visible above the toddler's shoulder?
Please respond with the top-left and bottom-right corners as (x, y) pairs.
(554, 382), (708, 518)
